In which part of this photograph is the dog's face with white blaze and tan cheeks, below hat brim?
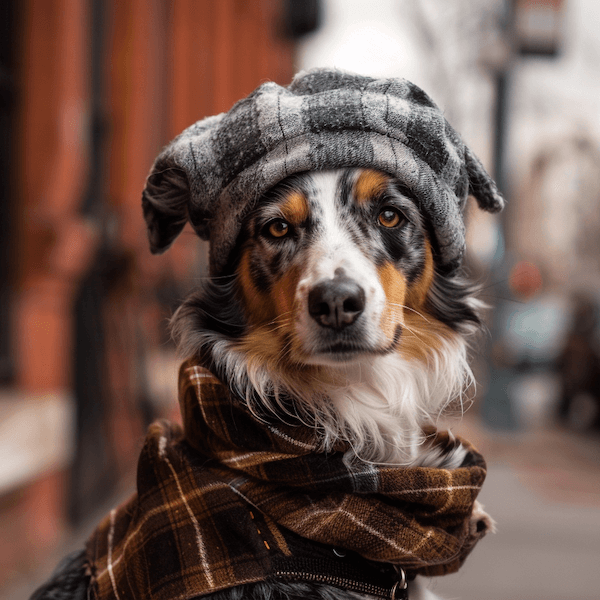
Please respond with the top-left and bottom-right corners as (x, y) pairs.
(236, 169), (464, 366)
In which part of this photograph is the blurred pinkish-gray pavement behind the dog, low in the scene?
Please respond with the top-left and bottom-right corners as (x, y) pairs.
(0, 416), (600, 600)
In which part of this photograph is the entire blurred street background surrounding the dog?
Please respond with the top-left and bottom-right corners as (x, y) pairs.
(0, 0), (600, 600)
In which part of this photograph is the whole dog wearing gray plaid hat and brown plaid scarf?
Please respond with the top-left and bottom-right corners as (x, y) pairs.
(30, 69), (502, 600)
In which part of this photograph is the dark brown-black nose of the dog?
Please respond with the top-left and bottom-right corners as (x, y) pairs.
(308, 269), (365, 329)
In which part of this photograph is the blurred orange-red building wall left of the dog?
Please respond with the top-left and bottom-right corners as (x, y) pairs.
(0, 0), (293, 584)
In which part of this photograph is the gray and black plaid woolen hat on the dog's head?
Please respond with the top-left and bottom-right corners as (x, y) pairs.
(142, 69), (504, 275)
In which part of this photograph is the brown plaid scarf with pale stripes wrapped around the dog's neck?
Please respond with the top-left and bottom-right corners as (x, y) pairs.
(88, 361), (485, 600)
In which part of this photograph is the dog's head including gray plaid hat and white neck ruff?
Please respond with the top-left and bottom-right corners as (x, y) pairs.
(143, 71), (502, 459)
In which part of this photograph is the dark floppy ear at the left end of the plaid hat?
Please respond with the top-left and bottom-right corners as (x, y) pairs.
(142, 160), (202, 254)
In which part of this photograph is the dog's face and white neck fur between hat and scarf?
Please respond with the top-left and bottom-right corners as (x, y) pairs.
(166, 169), (482, 598)
